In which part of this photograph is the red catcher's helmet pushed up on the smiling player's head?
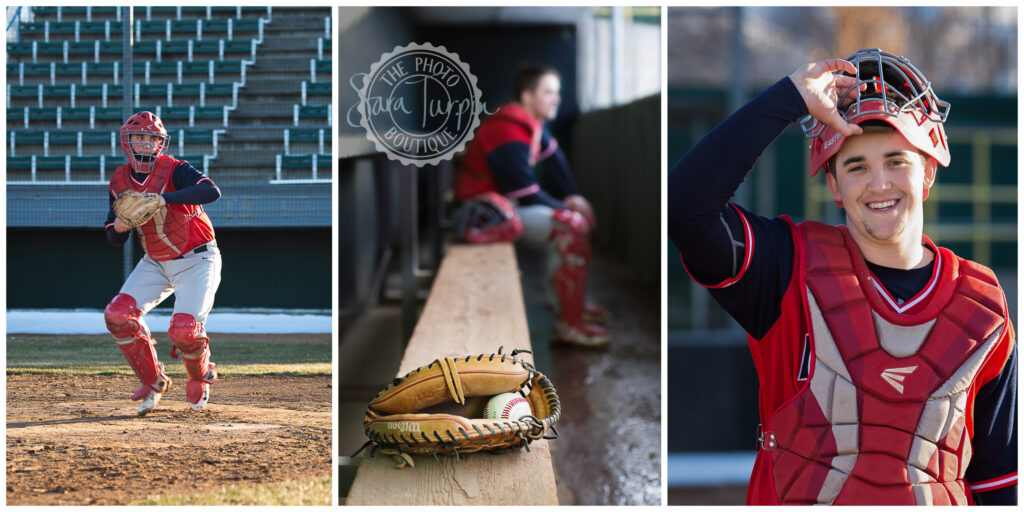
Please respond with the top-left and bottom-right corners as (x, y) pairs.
(800, 48), (949, 176)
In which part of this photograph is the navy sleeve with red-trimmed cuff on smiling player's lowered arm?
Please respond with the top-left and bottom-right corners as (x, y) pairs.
(965, 335), (1017, 505)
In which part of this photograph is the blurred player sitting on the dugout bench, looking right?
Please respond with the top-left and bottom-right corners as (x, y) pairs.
(455, 66), (608, 347)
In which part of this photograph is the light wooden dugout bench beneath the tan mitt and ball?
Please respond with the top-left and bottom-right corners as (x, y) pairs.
(345, 244), (558, 505)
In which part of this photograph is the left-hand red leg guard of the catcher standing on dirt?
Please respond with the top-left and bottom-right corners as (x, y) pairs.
(103, 293), (171, 400)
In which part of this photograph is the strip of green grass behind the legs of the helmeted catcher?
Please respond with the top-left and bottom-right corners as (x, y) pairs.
(7, 335), (331, 376)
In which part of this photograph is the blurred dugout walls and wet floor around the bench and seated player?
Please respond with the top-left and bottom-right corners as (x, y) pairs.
(337, 7), (660, 504)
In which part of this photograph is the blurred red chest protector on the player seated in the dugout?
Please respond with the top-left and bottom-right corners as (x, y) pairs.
(455, 102), (544, 201)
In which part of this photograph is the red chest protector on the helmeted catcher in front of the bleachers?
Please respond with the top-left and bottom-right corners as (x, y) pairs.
(111, 155), (213, 261)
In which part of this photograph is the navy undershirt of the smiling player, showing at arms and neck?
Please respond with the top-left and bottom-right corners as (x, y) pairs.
(668, 78), (1017, 505)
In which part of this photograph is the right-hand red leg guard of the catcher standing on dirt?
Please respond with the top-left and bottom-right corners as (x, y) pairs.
(167, 313), (217, 411)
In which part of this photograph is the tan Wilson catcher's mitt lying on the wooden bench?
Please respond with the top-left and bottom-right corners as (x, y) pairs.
(356, 347), (561, 468)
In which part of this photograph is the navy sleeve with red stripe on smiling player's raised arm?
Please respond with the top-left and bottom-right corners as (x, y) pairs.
(668, 78), (807, 339)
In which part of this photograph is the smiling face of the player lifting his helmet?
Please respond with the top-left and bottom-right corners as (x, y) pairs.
(825, 127), (936, 244)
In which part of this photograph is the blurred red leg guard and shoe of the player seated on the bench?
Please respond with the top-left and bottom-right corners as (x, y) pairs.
(551, 210), (608, 346)
